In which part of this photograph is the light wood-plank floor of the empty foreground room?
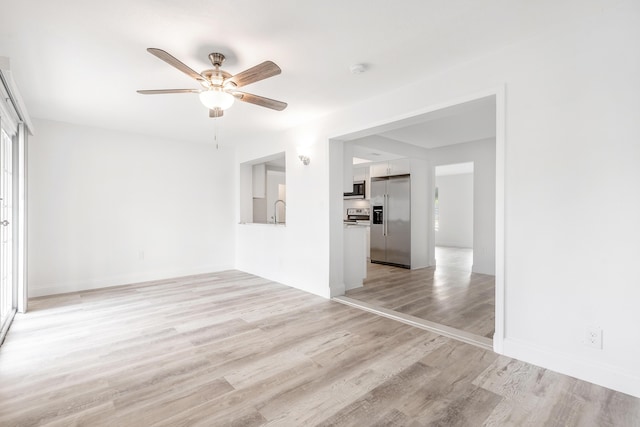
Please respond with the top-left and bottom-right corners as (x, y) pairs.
(0, 271), (640, 427)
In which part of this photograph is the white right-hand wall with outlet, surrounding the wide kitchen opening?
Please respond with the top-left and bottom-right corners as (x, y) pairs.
(238, 0), (640, 396)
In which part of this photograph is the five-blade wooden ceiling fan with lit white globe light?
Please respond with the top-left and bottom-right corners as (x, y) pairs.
(138, 47), (287, 117)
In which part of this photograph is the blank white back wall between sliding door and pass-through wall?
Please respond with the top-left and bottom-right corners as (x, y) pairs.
(28, 120), (235, 297)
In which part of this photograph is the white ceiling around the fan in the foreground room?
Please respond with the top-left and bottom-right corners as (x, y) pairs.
(0, 0), (607, 142)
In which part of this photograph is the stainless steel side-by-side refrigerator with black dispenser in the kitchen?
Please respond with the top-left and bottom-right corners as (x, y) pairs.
(371, 175), (411, 268)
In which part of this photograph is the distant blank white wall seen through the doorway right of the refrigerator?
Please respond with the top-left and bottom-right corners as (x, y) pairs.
(435, 173), (476, 248)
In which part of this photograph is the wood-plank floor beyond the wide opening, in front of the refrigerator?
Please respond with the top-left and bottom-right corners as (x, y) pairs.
(346, 247), (495, 338)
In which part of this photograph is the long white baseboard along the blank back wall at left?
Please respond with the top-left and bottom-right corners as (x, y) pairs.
(28, 265), (233, 298)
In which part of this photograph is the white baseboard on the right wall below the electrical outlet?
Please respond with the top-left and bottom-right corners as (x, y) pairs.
(503, 338), (640, 398)
